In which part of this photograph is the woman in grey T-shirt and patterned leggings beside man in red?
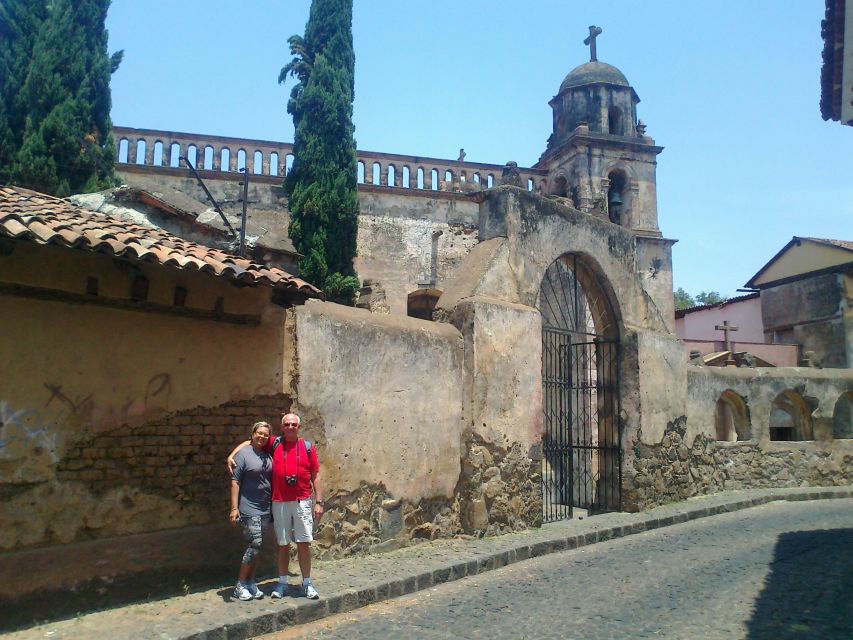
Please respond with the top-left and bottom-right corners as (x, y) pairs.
(229, 422), (272, 600)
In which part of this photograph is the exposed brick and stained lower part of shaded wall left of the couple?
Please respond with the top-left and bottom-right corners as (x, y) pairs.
(0, 394), (291, 610)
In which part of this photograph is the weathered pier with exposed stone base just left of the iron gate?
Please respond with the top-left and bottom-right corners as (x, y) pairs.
(442, 296), (542, 533)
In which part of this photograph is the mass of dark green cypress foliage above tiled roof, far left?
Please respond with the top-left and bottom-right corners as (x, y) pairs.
(0, 0), (122, 196)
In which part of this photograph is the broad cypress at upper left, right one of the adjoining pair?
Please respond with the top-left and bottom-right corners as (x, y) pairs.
(12, 0), (122, 196)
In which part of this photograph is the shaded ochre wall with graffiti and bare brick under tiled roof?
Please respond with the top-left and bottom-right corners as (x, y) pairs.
(0, 243), (304, 611)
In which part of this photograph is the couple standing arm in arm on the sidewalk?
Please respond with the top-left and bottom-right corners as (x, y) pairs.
(228, 413), (325, 600)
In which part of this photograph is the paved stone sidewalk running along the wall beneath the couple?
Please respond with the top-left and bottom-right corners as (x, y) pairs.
(7, 486), (853, 640)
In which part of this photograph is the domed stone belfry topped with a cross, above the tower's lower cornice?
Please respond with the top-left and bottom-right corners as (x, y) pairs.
(536, 26), (663, 237)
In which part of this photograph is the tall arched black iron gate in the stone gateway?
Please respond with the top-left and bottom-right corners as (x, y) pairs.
(537, 253), (622, 522)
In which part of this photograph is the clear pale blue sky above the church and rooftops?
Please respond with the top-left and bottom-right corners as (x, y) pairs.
(107, 0), (853, 296)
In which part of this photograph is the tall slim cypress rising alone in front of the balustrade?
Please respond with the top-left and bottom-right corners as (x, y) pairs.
(279, 0), (359, 304)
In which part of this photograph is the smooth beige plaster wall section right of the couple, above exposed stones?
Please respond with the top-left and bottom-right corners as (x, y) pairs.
(295, 302), (463, 501)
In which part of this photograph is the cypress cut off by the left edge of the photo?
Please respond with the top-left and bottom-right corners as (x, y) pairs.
(0, 0), (47, 183)
